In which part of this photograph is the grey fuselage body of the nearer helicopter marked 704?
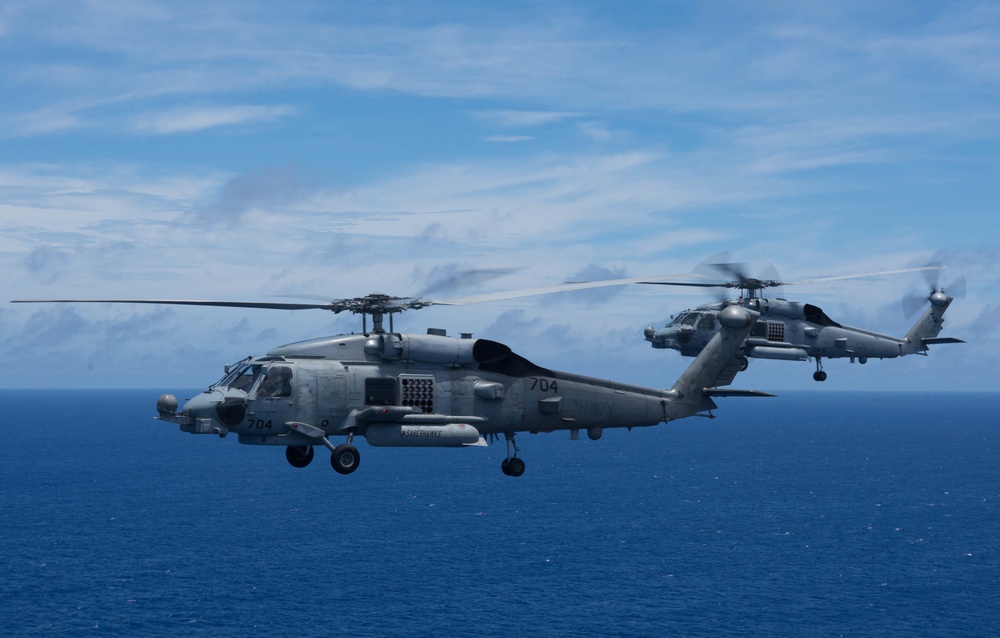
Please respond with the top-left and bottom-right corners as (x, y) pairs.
(158, 333), (696, 456)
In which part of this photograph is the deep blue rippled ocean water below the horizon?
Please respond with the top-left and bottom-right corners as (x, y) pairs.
(0, 390), (1000, 637)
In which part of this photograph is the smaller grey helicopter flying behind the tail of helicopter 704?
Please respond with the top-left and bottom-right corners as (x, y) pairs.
(640, 263), (965, 381)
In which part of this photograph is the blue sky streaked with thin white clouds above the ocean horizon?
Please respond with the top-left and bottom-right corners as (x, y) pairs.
(0, 0), (1000, 401)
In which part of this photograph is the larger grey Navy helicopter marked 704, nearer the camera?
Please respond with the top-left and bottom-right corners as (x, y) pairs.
(13, 284), (774, 477)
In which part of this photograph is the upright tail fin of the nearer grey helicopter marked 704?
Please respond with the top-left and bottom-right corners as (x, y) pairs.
(666, 306), (771, 419)
